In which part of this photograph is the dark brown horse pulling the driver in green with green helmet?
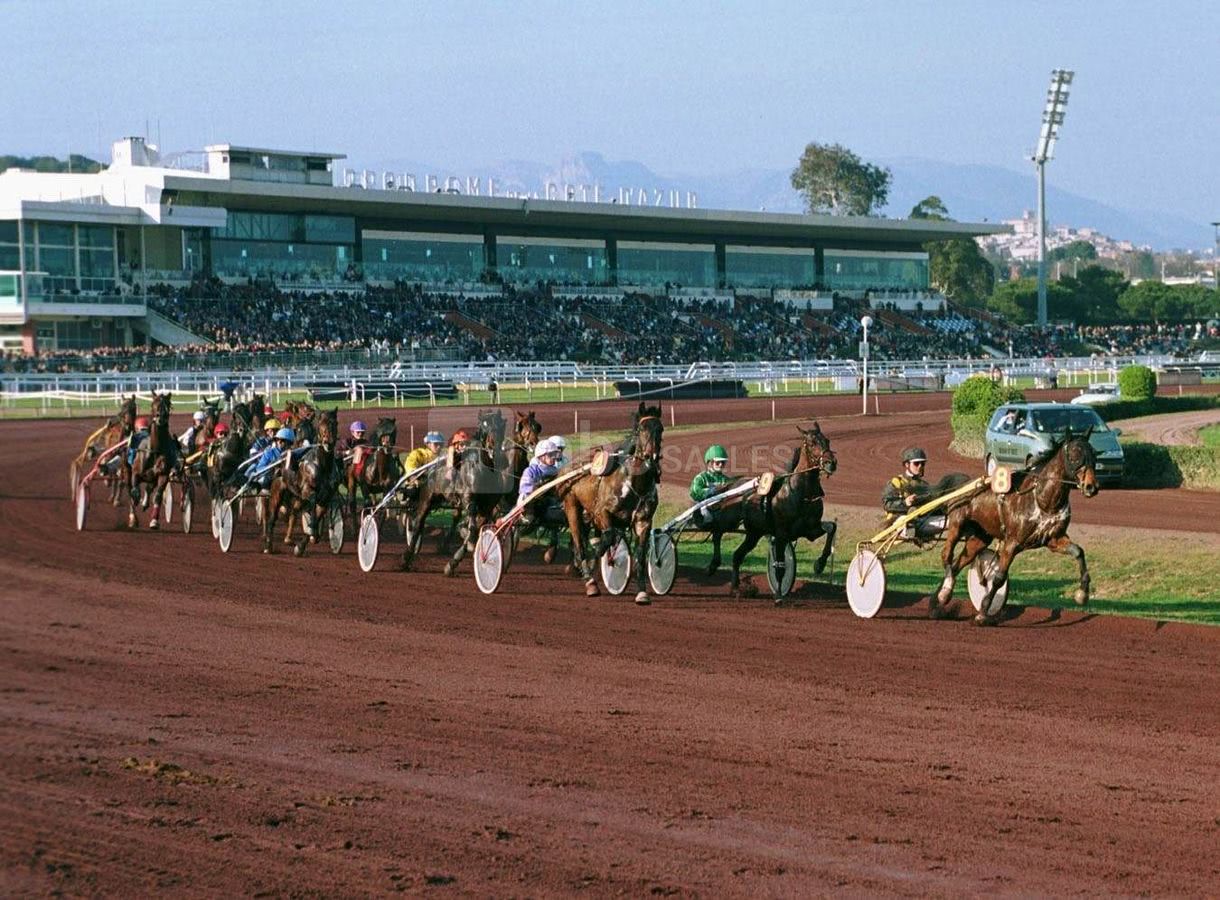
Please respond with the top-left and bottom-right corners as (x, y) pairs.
(711, 422), (838, 602)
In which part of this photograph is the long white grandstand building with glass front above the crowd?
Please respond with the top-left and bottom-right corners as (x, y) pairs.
(0, 138), (1008, 352)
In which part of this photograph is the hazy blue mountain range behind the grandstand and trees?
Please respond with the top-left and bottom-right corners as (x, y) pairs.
(362, 151), (1213, 250)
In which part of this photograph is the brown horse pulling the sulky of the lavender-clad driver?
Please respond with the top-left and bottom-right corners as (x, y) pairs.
(558, 402), (665, 605)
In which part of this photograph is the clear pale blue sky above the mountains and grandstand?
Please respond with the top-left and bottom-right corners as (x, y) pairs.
(0, 0), (1220, 222)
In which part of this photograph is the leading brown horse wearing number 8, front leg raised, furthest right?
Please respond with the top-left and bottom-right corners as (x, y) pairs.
(930, 428), (1098, 624)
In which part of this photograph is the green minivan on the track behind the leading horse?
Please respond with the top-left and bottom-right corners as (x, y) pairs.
(983, 404), (1122, 484)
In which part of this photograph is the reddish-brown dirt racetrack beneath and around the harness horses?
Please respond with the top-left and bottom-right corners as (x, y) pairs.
(0, 395), (1220, 896)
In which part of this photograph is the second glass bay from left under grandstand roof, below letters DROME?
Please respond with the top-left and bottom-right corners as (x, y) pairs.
(361, 230), (487, 284)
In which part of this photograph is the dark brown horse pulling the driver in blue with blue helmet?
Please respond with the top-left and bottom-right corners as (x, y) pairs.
(262, 410), (339, 556)
